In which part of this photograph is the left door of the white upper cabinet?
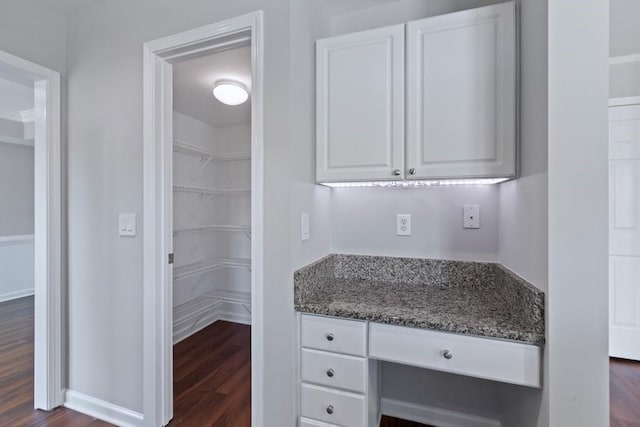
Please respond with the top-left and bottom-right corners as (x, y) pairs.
(316, 25), (404, 182)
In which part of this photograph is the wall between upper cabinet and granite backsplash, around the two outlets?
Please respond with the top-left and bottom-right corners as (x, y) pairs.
(331, 186), (499, 261)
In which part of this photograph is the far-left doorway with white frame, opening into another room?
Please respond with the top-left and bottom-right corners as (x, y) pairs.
(0, 51), (62, 410)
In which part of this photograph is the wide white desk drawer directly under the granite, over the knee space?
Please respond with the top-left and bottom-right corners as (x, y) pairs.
(369, 323), (540, 387)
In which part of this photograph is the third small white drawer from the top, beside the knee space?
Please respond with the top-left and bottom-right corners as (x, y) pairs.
(300, 384), (366, 427)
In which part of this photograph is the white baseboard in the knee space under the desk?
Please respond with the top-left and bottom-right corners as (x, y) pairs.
(381, 398), (502, 427)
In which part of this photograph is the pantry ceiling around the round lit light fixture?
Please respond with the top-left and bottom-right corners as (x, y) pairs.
(173, 46), (251, 127)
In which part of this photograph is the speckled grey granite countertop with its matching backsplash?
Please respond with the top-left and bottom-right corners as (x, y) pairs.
(294, 255), (545, 345)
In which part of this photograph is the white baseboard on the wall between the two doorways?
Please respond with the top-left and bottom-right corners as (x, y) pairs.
(64, 390), (143, 427)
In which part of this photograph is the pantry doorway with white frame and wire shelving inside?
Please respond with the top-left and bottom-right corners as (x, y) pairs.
(144, 12), (264, 427)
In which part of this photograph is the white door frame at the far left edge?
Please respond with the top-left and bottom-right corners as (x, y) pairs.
(0, 51), (62, 410)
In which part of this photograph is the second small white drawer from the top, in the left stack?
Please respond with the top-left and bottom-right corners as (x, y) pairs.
(302, 349), (367, 393)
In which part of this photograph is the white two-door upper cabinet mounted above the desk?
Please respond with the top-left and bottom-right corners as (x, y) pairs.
(316, 2), (517, 182)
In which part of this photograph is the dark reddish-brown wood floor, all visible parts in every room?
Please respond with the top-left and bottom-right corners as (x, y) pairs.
(0, 297), (640, 427)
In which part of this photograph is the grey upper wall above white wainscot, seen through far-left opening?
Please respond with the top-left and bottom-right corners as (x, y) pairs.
(0, 144), (34, 236)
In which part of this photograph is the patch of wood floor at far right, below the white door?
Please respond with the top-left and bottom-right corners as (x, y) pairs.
(609, 358), (640, 427)
